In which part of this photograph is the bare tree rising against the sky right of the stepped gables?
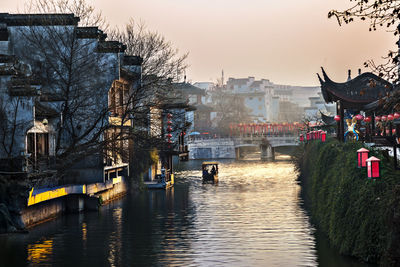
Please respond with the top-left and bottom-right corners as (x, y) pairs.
(109, 19), (188, 165)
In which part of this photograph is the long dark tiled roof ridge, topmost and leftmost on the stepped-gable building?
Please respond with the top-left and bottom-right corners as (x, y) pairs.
(0, 13), (79, 26)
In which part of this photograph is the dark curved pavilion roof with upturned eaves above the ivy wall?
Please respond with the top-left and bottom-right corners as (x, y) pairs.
(317, 68), (393, 109)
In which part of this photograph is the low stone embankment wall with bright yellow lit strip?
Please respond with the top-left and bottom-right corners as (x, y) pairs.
(0, 178), (127, 233)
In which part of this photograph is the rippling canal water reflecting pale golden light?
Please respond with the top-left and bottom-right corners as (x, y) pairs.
(0, 156), (374, 267)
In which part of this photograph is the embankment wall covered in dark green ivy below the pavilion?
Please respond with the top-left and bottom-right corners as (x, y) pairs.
(293, 140), (400, 266)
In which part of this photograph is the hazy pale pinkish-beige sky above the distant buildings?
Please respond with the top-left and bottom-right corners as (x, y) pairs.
(0, 0), (396, 85)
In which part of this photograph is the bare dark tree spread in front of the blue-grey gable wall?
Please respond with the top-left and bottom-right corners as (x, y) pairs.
(7, 15), (118, 176)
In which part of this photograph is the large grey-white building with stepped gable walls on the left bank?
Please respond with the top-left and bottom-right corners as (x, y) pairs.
(0, 13), (141, 183)
